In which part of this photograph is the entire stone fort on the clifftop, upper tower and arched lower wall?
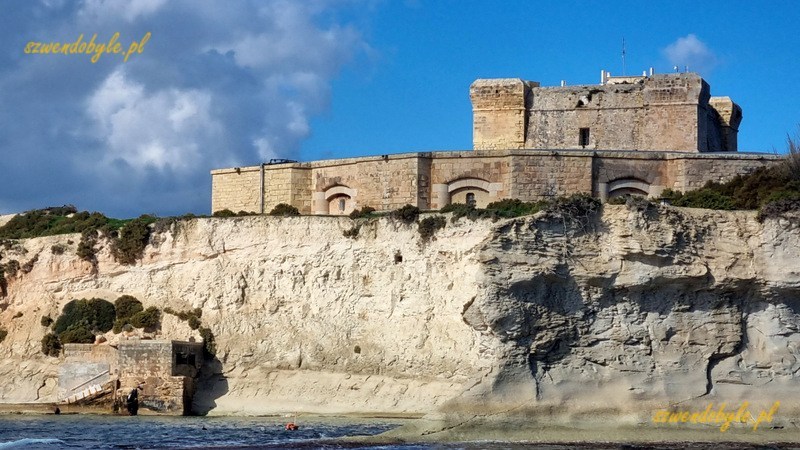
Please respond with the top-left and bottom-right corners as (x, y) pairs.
(211, 71), (779, 215)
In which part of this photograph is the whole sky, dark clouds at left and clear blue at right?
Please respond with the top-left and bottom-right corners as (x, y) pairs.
(0, 0), (800, 218)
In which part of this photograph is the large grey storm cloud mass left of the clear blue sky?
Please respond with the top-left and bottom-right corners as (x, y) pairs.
(0, 0), (366, 216)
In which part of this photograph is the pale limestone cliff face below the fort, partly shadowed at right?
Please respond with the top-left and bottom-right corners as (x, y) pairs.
(0, 206), (800, 415)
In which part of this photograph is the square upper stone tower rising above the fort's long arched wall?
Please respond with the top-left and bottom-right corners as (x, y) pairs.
(470, 73), (741, 152)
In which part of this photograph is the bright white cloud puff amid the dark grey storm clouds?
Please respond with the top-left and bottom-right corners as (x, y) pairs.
(87, 69), (222, 172)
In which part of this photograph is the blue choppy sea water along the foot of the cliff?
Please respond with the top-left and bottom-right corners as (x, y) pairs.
(0, 414), (797, 450)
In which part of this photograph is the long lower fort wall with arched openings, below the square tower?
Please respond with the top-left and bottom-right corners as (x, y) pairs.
(212, 149), (780, 215)
